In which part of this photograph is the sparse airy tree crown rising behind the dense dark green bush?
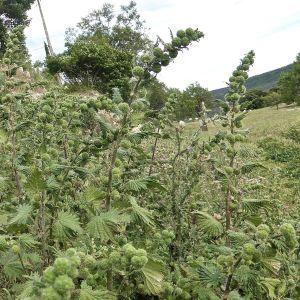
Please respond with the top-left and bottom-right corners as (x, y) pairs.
(67, 1), (151, 55)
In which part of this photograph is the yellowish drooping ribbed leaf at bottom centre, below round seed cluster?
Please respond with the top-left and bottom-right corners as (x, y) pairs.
(142, 259), (164, 295)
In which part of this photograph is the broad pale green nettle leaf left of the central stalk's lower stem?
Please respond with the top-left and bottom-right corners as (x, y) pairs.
(86, 210), (130, 241)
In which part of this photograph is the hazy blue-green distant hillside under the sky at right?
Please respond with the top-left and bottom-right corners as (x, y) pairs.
(211, 64), (292, 99)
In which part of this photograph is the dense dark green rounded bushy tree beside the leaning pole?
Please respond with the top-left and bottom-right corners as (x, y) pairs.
(47, 37), (132, 96)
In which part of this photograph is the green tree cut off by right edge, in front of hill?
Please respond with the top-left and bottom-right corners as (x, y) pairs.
(279, 54), (300, 105)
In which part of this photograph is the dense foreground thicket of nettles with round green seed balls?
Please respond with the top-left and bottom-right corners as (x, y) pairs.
(0, 21), (300, 300)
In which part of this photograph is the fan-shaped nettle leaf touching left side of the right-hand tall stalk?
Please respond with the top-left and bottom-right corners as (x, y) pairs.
(196, 211), (224, 237)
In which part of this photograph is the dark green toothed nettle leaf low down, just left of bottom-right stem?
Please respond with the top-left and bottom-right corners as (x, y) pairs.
(198, 264), (225, 287)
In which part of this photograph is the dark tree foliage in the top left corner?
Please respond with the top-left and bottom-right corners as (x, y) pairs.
(0, 0), (35, 54)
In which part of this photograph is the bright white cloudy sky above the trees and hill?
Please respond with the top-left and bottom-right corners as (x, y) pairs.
(26, 0), (300, 90)
